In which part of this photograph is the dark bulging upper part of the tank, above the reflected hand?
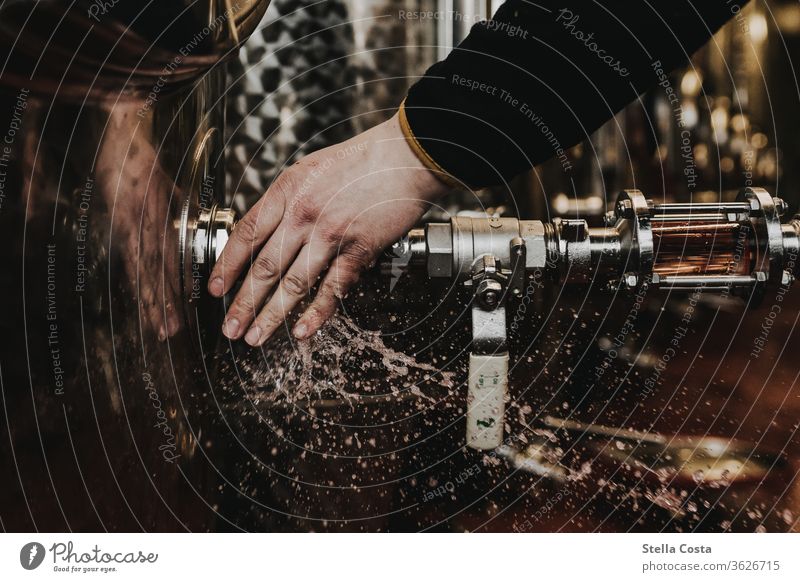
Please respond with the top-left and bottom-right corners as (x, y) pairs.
(0, 0), (269, 102)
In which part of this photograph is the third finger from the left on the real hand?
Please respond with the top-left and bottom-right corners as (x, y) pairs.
(244, 243), (334, 346)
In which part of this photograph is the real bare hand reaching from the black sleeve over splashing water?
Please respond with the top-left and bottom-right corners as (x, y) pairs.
(208, 115), (448, 346)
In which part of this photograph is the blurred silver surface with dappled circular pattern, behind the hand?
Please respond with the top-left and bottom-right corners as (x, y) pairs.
(227, 0), (360, 209)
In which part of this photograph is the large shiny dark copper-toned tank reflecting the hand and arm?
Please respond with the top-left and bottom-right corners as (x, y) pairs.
(0, 1), (267, 531)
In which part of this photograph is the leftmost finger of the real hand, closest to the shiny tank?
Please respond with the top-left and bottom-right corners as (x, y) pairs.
(208, 184), (285, 297)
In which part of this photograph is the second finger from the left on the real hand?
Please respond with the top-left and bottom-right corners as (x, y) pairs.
(222, 227), (304, 339)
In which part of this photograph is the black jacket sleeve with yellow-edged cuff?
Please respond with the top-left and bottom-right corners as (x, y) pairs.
(400, 0), (747, 187)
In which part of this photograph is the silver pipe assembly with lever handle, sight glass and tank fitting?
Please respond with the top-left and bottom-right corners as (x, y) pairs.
(180, 188), (800, 449)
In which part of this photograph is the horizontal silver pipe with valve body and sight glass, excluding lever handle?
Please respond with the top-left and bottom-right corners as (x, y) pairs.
(382, 188), (800, 296)
